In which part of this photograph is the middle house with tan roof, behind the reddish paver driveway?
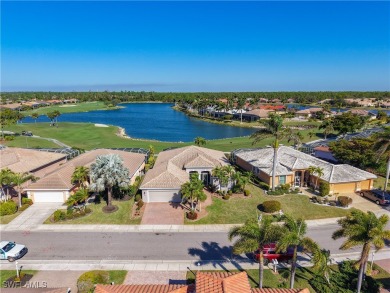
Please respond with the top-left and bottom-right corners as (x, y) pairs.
(140, 146), (229, 202)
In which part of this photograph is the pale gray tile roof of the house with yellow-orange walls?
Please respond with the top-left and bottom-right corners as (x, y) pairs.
(233, 146), (377, 183)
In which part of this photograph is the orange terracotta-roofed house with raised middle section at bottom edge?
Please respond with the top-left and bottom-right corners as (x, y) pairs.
(94, 272), (310, 293)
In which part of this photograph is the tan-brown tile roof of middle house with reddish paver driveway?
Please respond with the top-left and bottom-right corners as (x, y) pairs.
(140, 146), (228, 189)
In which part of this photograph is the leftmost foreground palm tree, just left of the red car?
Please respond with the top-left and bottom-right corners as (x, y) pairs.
(228, 217), (282, 288)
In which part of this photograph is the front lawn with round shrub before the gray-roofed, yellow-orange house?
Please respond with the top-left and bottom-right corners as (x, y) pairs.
(186, 185), (350, 224)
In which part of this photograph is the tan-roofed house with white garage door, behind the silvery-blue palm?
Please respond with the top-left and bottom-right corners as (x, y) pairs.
(25, 149), (146, 202)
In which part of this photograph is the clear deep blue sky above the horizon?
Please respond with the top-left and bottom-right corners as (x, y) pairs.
(1, 1), (390, 91)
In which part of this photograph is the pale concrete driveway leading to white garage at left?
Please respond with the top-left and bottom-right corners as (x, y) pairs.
(5, 203), (63, 230)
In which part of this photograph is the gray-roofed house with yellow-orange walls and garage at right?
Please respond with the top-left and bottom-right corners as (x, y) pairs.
(232, 146), (377, 194)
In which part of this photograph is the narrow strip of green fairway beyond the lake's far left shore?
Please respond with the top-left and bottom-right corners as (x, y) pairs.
(22, 102), (116, 116)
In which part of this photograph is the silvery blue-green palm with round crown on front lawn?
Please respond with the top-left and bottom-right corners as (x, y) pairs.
(89, 154), (130, 211)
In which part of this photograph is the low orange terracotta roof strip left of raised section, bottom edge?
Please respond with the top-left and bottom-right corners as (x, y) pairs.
(94, 285), (195, 293)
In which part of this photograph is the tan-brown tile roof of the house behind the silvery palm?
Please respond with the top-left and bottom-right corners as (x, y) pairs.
(25, 149), (145, 190)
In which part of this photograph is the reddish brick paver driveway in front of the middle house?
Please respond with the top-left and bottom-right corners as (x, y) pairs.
(141, 202), (184, 225)
